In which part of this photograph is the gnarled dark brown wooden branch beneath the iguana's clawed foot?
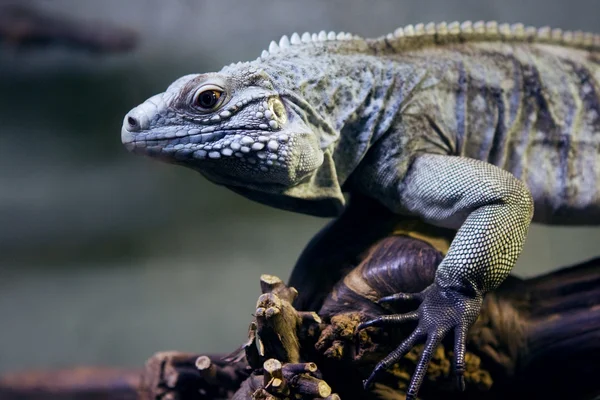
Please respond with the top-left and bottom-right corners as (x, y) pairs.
(0, 227), (600, 400)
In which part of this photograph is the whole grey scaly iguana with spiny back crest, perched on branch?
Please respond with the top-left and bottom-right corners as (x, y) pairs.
(121, 22), (600, 398)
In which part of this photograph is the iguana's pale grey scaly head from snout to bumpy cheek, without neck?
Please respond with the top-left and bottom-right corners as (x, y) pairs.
(121, 63), (323, 187)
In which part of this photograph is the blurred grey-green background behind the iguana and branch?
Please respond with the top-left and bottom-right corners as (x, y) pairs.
(0, 0), (600, 373)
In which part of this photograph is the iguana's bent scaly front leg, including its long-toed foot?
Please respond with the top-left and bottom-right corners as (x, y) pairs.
(359, 154), (533, 399)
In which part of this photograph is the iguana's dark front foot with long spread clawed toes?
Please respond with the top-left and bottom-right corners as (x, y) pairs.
(357, 283), (483, 400)
